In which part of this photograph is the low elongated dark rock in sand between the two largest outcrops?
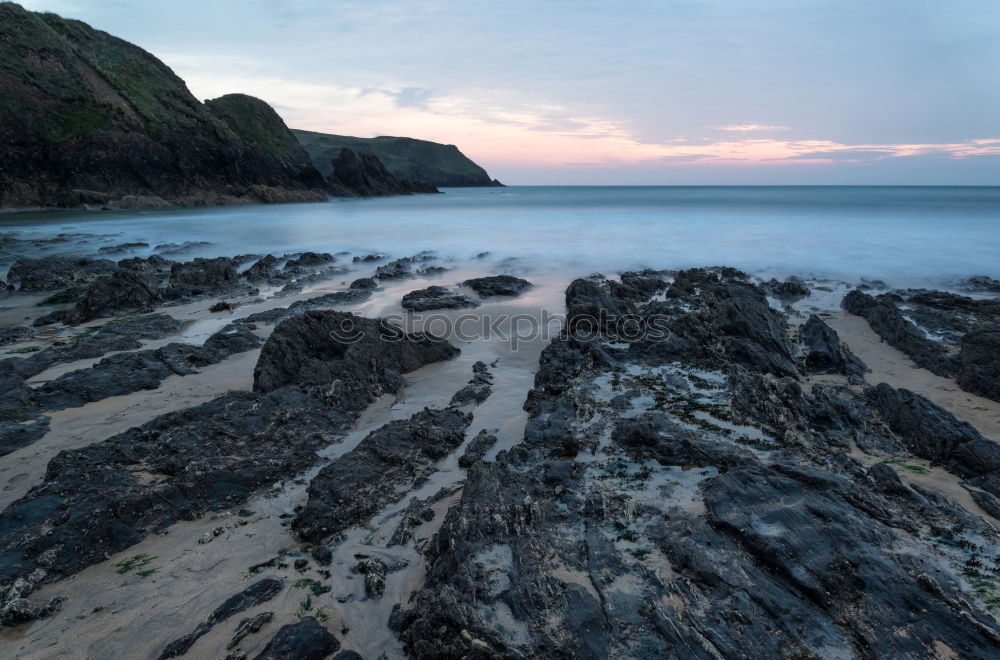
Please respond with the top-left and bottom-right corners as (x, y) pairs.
(292, 408), (472, 543)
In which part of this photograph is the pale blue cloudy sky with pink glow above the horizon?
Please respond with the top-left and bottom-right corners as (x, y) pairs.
(13, 0), (1000, 185)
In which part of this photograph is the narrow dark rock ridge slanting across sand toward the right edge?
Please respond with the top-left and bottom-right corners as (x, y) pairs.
(843, 289), (958, 378)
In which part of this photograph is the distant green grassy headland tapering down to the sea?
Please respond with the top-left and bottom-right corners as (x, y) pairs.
(292, 129), (503, 187)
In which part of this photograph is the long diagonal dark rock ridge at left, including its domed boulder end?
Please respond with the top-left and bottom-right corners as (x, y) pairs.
(0, 311), (460, 608)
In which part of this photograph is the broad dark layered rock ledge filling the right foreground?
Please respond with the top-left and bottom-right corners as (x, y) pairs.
(391, 270), (1000, 658)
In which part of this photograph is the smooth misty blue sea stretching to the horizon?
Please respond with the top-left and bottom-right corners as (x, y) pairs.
(0, 186), (1000, 286)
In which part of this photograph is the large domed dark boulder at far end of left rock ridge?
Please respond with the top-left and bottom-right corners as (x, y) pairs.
(254, 310), (458, 404)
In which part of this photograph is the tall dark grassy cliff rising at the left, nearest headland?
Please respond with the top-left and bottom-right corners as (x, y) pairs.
(0, 3), (326, 208)
